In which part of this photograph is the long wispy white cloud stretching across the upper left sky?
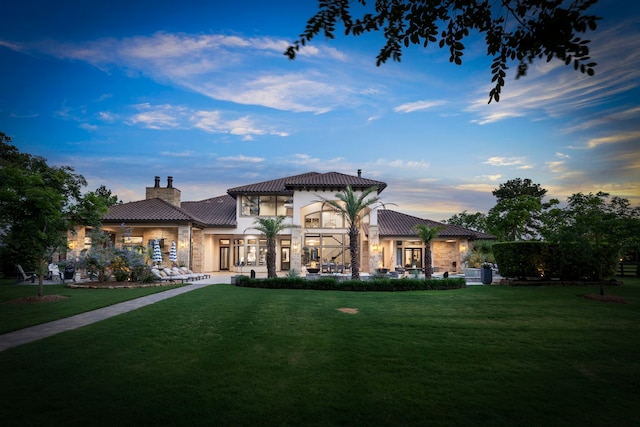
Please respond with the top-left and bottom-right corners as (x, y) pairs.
(4, 32), (356, 114)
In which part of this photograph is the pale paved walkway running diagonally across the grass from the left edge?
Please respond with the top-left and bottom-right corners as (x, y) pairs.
(0, 277), (228, 352)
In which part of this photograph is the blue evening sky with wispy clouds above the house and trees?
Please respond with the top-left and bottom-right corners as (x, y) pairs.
(0, 0), (640, 220)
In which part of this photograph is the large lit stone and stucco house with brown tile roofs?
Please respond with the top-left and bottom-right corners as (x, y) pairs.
(69, 170), (495, 273)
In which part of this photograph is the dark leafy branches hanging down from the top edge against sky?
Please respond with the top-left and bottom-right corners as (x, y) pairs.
(285, 0), (600, 102)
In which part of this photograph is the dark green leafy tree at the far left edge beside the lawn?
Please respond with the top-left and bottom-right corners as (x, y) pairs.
(0, 132), (106, 296)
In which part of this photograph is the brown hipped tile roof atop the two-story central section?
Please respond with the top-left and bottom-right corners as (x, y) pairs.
(227, 172), (387, 197)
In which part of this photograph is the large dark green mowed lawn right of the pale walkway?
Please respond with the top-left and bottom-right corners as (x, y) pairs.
(0, 279), (640, 426)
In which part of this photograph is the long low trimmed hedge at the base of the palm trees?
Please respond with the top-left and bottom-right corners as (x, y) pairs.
(235, 276), (467, 292)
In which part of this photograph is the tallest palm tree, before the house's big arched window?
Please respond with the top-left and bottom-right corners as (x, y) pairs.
(324, 185), (380, 280)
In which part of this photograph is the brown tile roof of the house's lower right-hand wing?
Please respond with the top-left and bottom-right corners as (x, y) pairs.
(378, 209), (496, 240)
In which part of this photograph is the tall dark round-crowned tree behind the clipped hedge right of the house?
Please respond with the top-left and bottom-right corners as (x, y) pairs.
(487, 178), (559, 242)
